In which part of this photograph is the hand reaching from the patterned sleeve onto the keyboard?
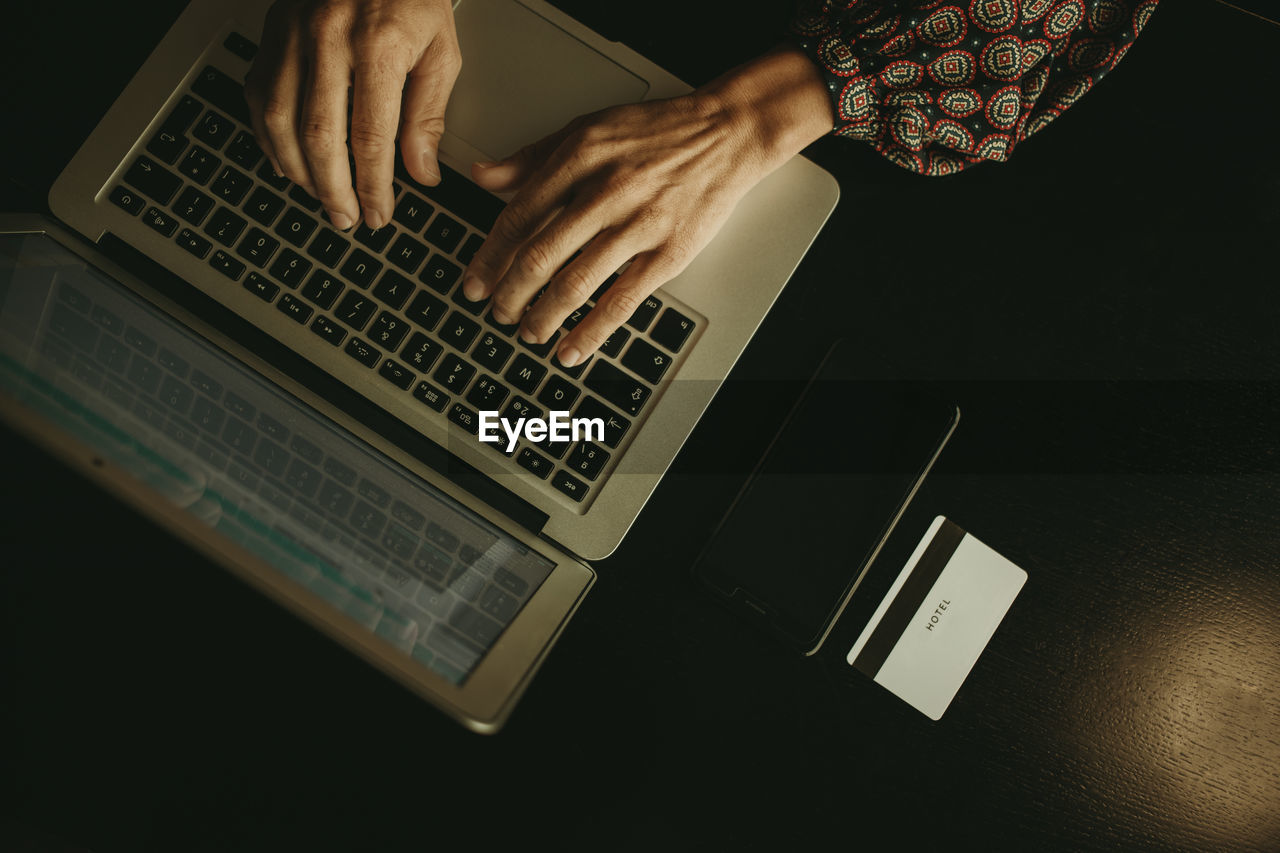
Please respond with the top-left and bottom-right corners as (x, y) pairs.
(463, 49), (833, 366)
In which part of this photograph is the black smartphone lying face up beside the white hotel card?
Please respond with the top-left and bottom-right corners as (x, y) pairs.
(692, 339), (960, 654)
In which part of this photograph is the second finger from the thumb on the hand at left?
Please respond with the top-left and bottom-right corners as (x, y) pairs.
(301, 36), (360, 231)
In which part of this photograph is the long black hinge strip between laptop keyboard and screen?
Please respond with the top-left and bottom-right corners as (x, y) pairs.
(97, 225), (548, 534)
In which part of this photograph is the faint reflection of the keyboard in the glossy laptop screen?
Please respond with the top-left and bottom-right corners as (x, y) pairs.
(24, 266), (550, 683)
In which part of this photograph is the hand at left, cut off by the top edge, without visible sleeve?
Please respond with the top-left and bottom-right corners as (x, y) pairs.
(244, 0), (462, 231)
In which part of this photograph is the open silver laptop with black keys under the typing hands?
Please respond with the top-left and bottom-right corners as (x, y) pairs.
(0, 0), (838, 731)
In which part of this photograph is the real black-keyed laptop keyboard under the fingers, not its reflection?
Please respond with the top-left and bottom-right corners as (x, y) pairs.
(108, 33), (698, 510)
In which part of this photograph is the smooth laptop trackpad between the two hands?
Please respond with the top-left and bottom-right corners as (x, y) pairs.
(444, 0), (649, 159)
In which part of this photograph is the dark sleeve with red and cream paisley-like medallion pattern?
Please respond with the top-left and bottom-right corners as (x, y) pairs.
(794, 0), (1160, 175)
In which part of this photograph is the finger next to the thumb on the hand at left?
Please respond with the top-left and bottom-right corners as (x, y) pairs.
(351, 59), (403, 229)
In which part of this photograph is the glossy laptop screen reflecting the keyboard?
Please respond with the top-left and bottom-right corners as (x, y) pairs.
(0, 234), (554, 684)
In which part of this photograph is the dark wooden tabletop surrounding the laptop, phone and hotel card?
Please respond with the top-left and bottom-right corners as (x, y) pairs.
(0, 0), (1280, 850)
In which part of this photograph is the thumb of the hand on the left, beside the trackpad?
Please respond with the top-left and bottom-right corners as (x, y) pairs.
(399, 33), (462, 187)
